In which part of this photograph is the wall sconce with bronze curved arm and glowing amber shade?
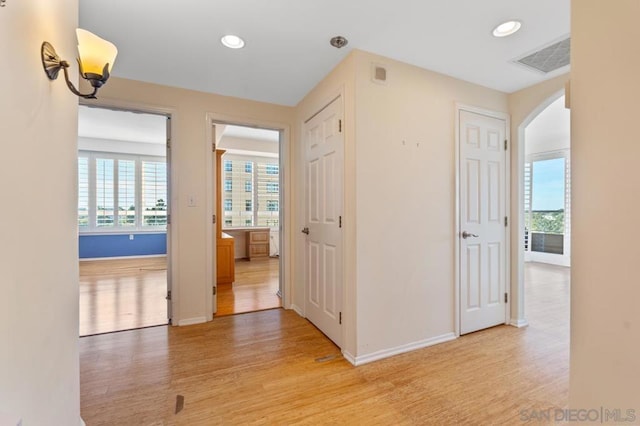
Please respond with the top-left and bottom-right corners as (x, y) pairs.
(40, 28), (118, 99)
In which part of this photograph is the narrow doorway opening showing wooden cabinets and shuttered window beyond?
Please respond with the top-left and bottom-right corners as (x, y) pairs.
(214, 123), (284, 316)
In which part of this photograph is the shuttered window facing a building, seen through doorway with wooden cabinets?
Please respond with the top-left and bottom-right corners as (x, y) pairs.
(223, 154), (280, 227)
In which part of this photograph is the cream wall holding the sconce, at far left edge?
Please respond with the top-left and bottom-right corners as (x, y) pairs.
(0, 0), (80, 426)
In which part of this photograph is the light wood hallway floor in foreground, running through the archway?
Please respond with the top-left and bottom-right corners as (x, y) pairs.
(80, 264), (569, 426)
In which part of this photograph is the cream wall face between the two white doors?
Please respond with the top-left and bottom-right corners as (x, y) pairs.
(347, 52), (507, 359)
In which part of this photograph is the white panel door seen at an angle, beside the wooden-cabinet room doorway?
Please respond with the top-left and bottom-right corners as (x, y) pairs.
(302, 98), (344, 346)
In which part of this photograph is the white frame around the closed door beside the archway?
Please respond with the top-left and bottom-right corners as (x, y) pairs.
(453, 102), (513, 337)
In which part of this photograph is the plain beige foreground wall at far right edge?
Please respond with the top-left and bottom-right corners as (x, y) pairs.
(570, 0), (640, 412)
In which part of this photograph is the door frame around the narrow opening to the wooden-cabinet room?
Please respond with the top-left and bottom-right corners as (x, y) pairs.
(204, 112), (293, 321)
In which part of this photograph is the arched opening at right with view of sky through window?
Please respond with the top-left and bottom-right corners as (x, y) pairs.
(521, 95), (571, 330)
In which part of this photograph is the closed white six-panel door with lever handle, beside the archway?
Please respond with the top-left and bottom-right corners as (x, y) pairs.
(458, 110), (507, 334)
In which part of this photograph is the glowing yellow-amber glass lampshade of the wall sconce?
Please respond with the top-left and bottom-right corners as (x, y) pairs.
(76, 28), (118, 78)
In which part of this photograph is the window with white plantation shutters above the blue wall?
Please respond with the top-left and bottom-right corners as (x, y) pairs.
(78, 151), (167, 232)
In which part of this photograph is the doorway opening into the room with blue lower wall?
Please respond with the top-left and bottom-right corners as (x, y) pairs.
(78, 105), (170, 336)
